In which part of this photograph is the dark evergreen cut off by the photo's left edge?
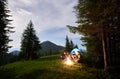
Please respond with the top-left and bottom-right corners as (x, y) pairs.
(0, 0), (13, 65)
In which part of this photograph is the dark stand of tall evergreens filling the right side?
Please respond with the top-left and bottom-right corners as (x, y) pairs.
(68, 0), (120, 78)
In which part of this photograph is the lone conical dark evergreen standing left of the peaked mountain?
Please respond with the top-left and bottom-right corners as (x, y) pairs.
(20, 21), (41, 60)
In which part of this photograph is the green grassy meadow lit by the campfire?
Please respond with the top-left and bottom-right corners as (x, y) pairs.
(0, 55), (110, 79)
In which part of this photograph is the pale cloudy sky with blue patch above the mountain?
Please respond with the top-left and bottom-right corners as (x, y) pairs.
(8, 0), (85, 51)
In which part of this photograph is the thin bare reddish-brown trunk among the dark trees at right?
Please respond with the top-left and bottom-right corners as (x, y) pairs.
(102, 31), (107, 71)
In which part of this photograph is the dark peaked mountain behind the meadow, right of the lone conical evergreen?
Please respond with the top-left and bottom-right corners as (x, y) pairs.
(40, 41), (65, 55)
